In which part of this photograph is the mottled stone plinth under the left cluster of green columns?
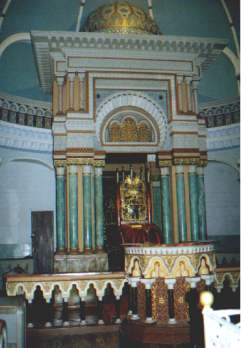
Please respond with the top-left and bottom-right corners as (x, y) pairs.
(54, 253), (108, 273)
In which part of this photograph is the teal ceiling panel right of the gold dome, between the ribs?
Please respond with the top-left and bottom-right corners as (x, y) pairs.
(152, 0), (234, 47)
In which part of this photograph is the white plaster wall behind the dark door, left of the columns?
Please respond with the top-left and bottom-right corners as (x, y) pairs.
(0, 147), (55, 257)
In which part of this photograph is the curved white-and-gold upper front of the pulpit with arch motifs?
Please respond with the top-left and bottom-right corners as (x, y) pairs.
(125, 243), (216, 279)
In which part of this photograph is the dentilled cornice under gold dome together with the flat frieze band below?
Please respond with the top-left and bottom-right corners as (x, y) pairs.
(31, 31), (226, 92)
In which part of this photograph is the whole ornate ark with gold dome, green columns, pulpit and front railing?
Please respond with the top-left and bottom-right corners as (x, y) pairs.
(4, 3), (240, 346)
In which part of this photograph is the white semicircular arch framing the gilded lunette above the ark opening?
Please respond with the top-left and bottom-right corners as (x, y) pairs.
(96, 91), (168, 150)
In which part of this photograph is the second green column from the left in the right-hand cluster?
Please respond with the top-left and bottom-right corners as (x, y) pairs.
(176, 166), (187, 242)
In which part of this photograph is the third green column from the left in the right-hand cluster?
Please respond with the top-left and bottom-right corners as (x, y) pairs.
(188, 166), (199, 241)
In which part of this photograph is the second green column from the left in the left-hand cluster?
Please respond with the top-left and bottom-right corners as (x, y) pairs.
(69, 165), (78, 251)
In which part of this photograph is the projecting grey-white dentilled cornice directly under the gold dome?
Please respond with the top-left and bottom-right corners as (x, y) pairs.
(31, 31), (227, 93)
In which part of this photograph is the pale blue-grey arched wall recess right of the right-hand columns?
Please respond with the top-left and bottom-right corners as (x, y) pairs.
(205, 161), (240, 238)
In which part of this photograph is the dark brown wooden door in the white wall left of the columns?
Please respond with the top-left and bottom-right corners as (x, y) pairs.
(31, 211), (54, 273)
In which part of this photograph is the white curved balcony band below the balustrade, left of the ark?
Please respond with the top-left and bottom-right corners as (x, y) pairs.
(0, 121), (53, 153)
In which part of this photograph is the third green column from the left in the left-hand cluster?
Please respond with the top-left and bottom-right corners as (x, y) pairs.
(83, 165), (92, 251)
